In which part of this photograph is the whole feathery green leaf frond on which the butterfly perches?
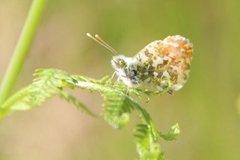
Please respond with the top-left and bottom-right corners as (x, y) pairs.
(0, 69), (179, 160)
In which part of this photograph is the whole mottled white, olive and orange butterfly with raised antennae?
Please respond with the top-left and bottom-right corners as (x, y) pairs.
(87, 33), (193, 93)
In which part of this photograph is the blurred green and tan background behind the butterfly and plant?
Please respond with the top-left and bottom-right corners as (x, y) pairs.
(0, 0), (240, 160)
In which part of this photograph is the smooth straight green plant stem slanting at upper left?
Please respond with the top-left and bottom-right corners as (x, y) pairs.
(0, 0), (47, 105)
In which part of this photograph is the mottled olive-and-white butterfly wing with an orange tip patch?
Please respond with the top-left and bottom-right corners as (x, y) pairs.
(135, 35), (192, 91)
